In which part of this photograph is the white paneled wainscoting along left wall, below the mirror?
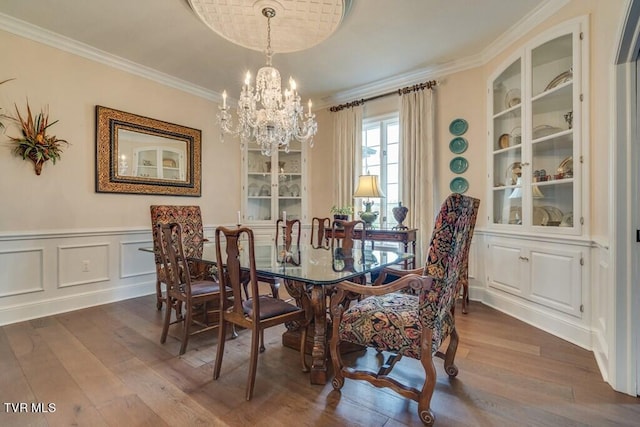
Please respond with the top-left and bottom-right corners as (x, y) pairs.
(0, 227), (155, 325)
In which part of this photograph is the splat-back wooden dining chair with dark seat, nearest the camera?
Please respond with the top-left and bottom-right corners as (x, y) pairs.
(213, 227), (311, 400)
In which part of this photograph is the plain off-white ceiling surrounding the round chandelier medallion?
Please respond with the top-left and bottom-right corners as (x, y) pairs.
(0, 0), (552, 106)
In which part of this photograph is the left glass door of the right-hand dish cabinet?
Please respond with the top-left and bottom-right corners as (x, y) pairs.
(491, 58), (523, 226)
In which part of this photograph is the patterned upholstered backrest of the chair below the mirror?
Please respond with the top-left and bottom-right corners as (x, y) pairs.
(150, 205), (205, 264)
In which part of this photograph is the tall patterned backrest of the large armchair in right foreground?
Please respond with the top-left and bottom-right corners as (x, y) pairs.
(420, 193), (480, 328)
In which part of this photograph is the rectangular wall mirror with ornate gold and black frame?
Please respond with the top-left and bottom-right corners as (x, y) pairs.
(96, 106), (201, 196)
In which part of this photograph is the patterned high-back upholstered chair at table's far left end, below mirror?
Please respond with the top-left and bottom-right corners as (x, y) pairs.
(150, 205), (212, 310)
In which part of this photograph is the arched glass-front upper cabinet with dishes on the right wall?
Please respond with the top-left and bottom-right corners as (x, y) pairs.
(488, 21), (588, 234)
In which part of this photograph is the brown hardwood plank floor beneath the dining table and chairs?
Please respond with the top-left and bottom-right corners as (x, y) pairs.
(0, 295), (640, 427)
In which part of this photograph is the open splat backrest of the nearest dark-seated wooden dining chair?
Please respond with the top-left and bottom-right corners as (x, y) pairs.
(216, 226), (260, 322)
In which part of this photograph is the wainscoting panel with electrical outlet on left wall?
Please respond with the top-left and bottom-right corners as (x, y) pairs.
(58, 243), (109, 288)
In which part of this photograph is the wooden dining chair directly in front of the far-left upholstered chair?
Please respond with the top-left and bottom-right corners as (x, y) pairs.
(156, 222), (220, 355)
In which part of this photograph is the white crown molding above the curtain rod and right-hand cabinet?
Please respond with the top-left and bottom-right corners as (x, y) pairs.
(318, 0), (571, 108)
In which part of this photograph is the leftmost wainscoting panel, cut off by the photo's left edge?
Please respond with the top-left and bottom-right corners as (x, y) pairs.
(0, 248), (44, 299)
